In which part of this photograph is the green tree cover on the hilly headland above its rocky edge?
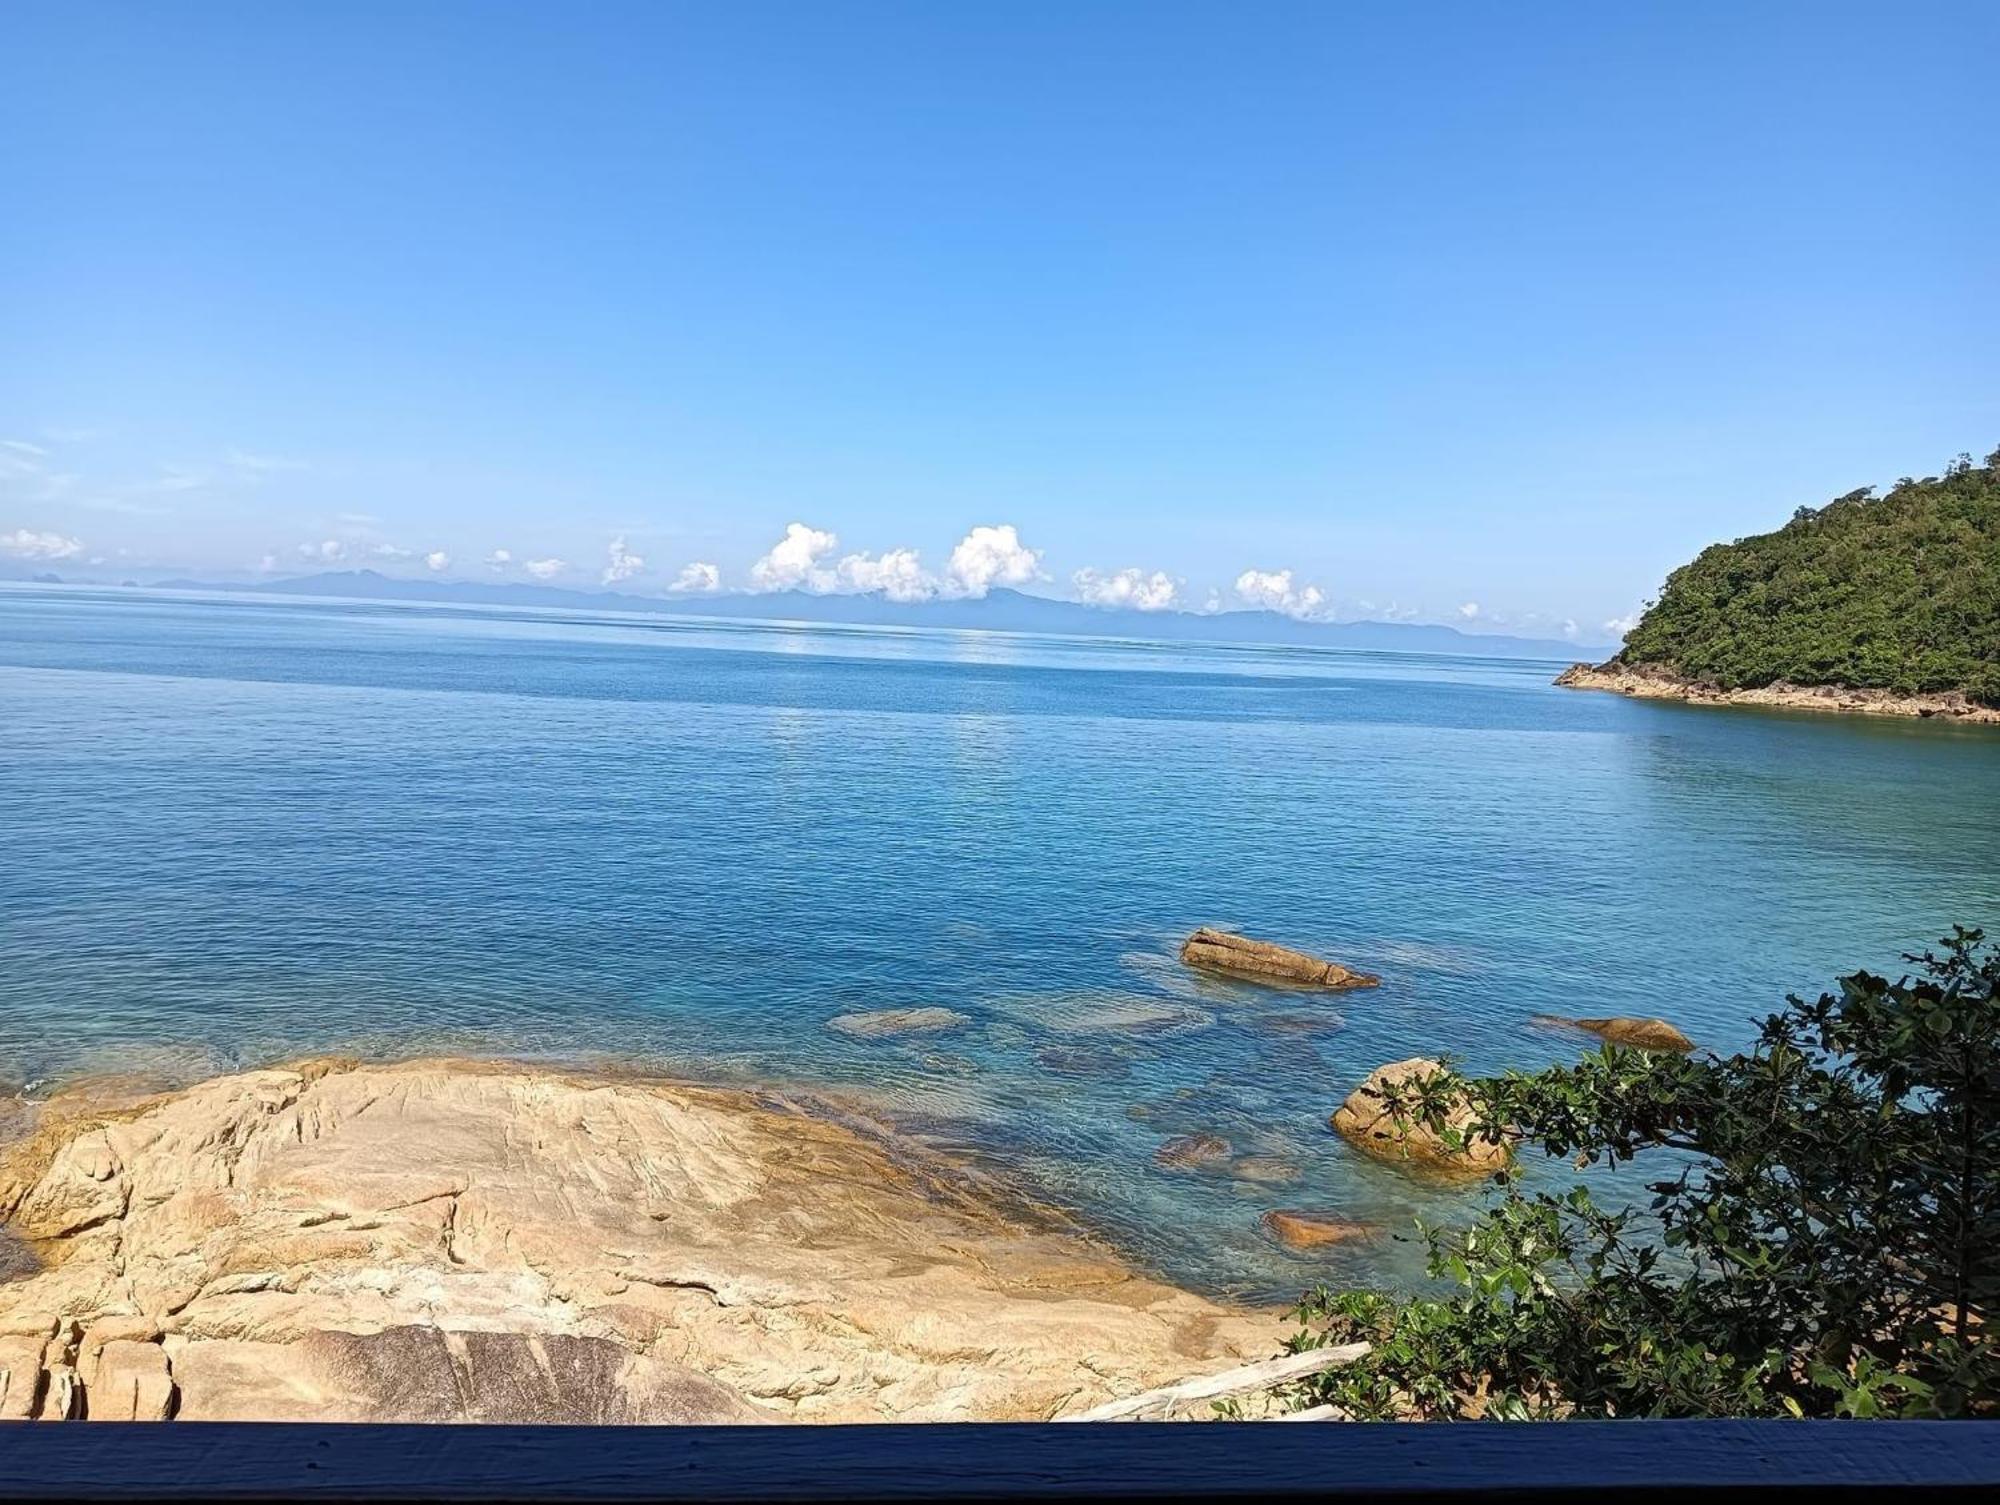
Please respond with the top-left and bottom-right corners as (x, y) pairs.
(1618, 450), (2000, 704)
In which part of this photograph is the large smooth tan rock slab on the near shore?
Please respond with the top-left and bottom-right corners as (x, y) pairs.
(0, 1063), (1276, 1421)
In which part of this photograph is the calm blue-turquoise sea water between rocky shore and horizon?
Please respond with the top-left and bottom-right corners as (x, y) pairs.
(0, 586), (2000, 1295)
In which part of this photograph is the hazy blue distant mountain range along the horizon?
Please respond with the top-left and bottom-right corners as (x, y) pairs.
(16, 570), (1610, 662)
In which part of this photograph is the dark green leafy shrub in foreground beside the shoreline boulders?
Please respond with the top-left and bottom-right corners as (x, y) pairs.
(1290, 929), (2000, 1419)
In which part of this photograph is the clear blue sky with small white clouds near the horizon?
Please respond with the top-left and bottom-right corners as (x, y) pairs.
(0, 0), (2000, 640)
